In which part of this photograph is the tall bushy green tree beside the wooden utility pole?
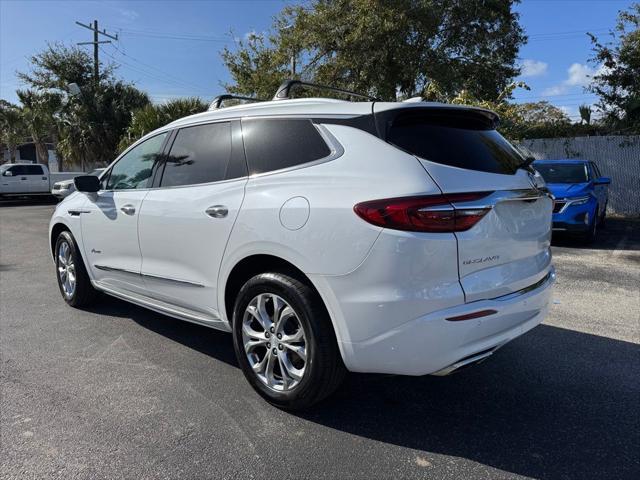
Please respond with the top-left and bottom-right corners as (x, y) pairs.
(18, 44), (149, 169)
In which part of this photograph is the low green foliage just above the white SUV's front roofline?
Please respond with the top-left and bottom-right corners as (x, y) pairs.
(119, 97), (208, 151)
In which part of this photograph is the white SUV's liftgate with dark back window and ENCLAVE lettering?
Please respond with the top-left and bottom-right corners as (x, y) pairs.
(378, 108), (553, 302)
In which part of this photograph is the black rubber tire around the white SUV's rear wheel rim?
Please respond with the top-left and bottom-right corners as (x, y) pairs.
(233, 273), (346, 410)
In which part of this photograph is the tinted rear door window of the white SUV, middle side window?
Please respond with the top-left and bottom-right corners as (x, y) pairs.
(160, 122), (231, 187)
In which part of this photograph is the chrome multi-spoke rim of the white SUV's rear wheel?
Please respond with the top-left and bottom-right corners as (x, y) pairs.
(242, 293), (307, 392)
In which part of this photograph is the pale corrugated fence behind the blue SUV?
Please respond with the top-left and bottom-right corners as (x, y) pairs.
(519, 135), (640, 216)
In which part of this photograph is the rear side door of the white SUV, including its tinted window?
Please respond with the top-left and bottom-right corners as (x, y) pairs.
(139, 122), (247, 322)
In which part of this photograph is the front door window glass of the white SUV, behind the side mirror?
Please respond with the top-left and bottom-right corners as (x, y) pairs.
(107, 132), (167, 190)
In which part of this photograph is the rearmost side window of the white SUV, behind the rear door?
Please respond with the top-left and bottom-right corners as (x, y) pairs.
(242, 118), (331, 175)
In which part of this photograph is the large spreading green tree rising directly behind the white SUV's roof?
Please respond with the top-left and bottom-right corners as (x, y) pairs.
(222, 0), (526, 100)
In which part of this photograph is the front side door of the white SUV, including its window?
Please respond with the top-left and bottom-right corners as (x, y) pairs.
(81, 133), (167, 293)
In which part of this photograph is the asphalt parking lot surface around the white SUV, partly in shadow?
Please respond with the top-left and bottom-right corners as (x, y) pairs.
(0, 202), (640, 479)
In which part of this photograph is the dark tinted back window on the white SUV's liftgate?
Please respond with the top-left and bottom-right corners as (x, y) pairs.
(387, 112), (524, 174)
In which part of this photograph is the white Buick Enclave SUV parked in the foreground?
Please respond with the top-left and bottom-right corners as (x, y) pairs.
(50, 82), (555, 409)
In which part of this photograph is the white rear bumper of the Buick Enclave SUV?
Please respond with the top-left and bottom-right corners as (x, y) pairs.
(341, 267), (555, 375)
